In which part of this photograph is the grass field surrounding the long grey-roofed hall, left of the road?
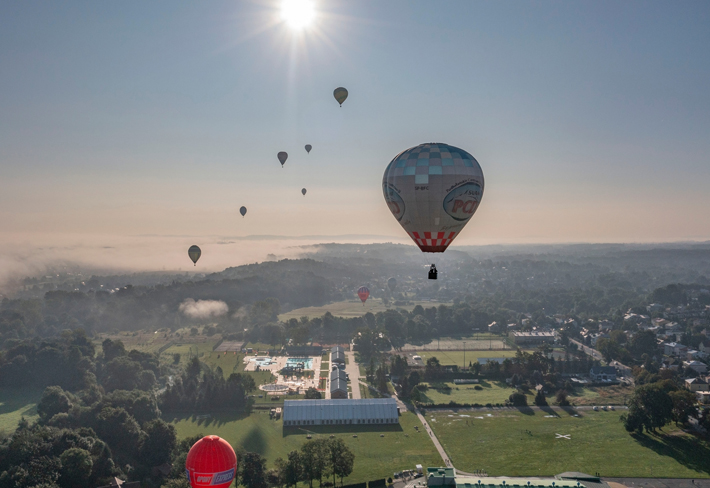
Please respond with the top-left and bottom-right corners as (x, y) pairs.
(174, 411), (442, 484)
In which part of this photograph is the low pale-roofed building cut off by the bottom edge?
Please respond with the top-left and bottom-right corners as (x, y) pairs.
(426, 468), (610, 488)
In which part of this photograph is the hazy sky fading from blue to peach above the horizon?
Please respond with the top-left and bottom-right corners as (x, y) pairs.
(0, 0), (710, 266)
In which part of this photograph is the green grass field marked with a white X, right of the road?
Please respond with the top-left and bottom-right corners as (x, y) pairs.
(427, 409), (710, 478)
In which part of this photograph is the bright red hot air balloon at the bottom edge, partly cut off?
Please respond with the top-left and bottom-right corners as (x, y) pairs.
(185, 435), (237, 488)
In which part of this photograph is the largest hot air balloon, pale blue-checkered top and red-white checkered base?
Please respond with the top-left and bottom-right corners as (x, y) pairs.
(382, 143), (484, 279)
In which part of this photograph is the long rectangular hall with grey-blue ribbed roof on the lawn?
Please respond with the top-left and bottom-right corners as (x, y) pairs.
(283, 398), (399, 427)
